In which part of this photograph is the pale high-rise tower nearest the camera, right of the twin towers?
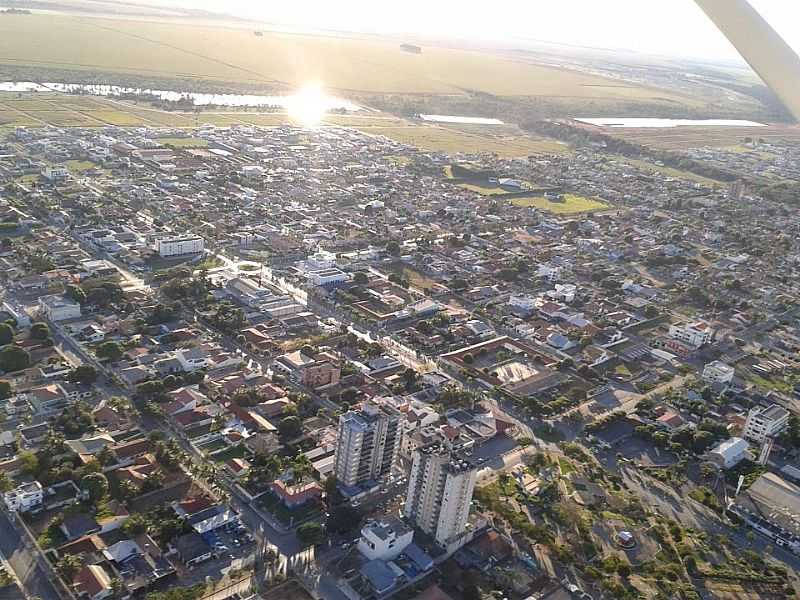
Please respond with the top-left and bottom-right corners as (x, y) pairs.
(403, 442), (478, 552)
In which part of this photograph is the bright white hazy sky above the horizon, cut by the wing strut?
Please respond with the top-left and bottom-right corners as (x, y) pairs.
(144, 0), (800, 60)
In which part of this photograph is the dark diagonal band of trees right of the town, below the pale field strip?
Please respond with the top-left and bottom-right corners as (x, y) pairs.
(522, 121), (740, 182)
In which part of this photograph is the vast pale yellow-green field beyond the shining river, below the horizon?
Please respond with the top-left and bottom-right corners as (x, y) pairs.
(0, 14), (696, 106)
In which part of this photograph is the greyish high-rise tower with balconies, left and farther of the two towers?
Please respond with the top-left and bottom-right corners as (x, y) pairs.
(333, 404), (402, 489)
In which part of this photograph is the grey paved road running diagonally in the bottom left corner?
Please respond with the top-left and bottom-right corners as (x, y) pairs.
(0, 510), (62, 600)
